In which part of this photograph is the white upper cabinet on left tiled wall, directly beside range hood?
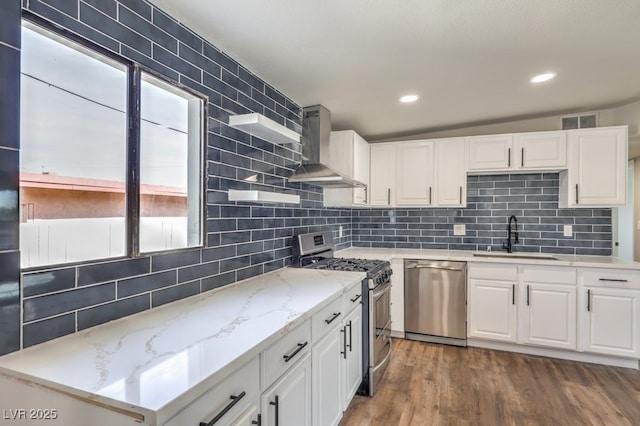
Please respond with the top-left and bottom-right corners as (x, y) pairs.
(324, 130), (370, 207)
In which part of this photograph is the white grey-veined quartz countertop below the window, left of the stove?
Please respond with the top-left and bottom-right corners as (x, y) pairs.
(0, 268), (365, 424)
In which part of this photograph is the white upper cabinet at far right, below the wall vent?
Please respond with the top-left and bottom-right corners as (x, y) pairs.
(558, 126), (628, 208)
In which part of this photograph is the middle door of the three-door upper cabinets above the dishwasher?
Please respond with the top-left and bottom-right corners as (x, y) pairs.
(395, 141), (434, 206)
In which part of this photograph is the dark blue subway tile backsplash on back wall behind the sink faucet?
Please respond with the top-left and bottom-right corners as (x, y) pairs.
(352, 173), (612, 255)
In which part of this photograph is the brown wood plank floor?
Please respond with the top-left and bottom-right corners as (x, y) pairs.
(340, 339), (640, 426)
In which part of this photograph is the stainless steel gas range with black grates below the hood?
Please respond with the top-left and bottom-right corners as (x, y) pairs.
(293, 232), (392, 396)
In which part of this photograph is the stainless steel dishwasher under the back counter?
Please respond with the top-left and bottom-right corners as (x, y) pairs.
(404, 259), (467, 346)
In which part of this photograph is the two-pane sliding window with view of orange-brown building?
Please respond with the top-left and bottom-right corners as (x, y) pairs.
(20, 22), (204, 267)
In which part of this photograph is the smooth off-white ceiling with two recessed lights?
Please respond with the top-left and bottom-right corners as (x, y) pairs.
(151, 0), (640, 140)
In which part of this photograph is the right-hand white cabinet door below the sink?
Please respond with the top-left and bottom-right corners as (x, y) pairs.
(523, 282), (577, 350)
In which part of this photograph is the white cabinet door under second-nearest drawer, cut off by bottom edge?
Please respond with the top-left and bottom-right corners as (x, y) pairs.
(261, 354), (311, 426)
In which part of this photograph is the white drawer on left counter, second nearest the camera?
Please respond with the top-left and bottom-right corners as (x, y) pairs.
(260, 320), (311, 390)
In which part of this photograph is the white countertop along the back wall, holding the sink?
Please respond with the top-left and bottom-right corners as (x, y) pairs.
(334, 247), (640, 271)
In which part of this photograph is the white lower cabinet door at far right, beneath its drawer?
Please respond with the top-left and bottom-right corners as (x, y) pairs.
(584, 287), (640, 358)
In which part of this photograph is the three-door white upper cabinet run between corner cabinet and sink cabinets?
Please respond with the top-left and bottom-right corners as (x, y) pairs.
(370, 138), (467, 207)
